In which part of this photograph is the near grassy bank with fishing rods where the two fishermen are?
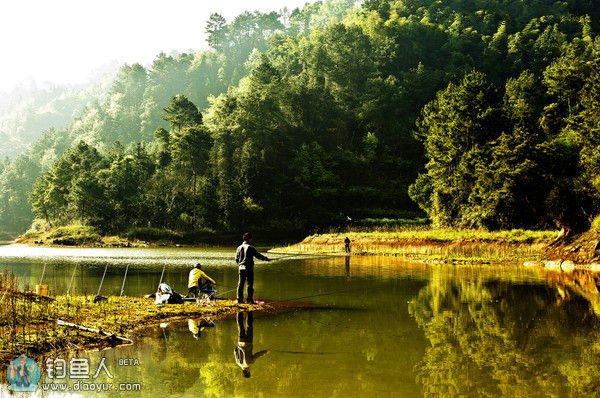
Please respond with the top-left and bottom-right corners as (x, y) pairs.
(0, 274), (266, 362)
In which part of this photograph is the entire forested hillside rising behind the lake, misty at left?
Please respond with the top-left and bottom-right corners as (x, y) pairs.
(0, 0), (600, 238)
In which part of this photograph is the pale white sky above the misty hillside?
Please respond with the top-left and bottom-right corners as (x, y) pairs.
(0, 0), (313, 91)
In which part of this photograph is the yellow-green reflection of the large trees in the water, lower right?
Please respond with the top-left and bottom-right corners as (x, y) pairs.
(409, 269), (600, 397)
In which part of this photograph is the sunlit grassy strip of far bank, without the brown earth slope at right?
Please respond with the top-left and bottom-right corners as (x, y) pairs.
(273, 227), (556, 261)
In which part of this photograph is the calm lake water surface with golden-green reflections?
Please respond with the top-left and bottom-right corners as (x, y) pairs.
(0, 246), (600, 397)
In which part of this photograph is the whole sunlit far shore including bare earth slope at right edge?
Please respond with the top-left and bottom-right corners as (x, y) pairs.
(271, 228), (600, 271)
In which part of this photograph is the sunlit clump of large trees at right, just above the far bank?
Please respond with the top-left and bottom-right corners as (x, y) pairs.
(410, 38), (600, 229)
